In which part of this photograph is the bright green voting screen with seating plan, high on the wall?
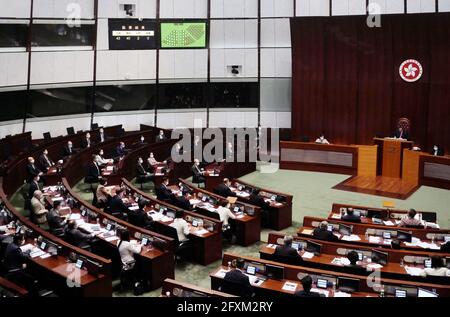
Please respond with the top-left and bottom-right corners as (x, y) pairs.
(161, 22), (206, 48)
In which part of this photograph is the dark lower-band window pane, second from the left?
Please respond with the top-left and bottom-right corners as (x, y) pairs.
(28, 87), (92, 118)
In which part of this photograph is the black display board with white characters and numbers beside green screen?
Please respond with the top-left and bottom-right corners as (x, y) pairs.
(109, 19), (157, 50)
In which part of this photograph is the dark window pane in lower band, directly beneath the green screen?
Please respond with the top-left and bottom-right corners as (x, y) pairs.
(159, 83), (207, 109)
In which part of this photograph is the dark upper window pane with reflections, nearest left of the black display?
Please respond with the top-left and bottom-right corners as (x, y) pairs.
(31, 24), (94, 46)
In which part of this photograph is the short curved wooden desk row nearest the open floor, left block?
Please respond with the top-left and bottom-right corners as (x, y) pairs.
(231, 179), (293, 230)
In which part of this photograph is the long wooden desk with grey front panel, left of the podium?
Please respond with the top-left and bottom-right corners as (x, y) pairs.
(280, 141), (358, 175)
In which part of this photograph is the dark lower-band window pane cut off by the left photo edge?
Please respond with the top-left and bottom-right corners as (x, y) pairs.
(0, 91), (27, 121)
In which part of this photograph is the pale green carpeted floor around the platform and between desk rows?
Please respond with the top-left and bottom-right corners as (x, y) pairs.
(12, 170), (450, 296)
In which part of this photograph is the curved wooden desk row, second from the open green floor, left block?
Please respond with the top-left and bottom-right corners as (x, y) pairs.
(173, 179), (261, 246)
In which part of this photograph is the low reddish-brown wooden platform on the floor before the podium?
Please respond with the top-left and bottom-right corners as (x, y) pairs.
(333, 176), (420, 200)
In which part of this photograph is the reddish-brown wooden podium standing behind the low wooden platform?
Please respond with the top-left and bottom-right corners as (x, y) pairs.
(373, 138), (413, 178)
